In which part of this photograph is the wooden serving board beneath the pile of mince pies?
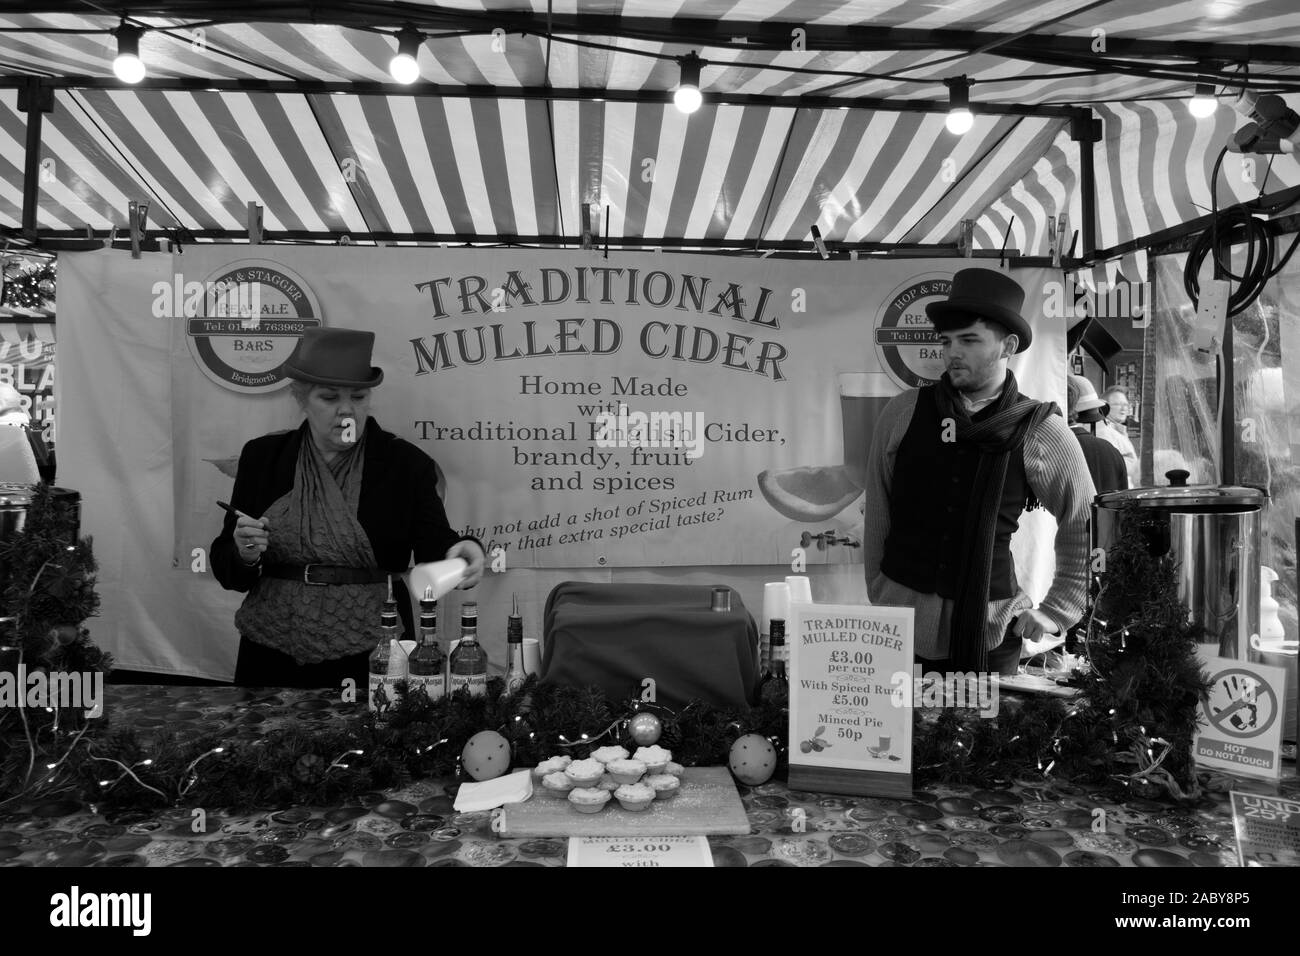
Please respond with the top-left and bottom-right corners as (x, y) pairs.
(502, 767), (749, 836)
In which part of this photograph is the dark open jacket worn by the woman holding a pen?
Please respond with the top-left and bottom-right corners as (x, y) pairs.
(209, 418), (475, 636)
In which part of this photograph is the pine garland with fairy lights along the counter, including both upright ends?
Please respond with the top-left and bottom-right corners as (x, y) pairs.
(0, 502), (1208, 810)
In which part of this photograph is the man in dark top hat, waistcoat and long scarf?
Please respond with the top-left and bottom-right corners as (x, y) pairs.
(862, 269), (1093, 674)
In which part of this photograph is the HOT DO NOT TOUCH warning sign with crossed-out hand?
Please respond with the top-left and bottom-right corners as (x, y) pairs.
(1192, 650), (1287, 780)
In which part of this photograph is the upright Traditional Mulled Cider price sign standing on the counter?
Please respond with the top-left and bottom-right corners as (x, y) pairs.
(788, 604), (915, 796)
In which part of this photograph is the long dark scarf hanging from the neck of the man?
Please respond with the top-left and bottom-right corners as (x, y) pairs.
(933, 369), (1060, 671)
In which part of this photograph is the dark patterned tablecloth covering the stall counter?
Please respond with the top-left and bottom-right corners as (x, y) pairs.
(0, 687), (1300, 866)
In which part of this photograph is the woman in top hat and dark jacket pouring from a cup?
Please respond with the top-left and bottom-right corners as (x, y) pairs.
(211, 328), (484, 687)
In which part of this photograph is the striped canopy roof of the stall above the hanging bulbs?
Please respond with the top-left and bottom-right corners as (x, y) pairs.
(0, 0), (1300, 265)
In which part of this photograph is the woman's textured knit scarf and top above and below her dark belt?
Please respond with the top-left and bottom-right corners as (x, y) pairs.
(235, 423), (386, 665)
